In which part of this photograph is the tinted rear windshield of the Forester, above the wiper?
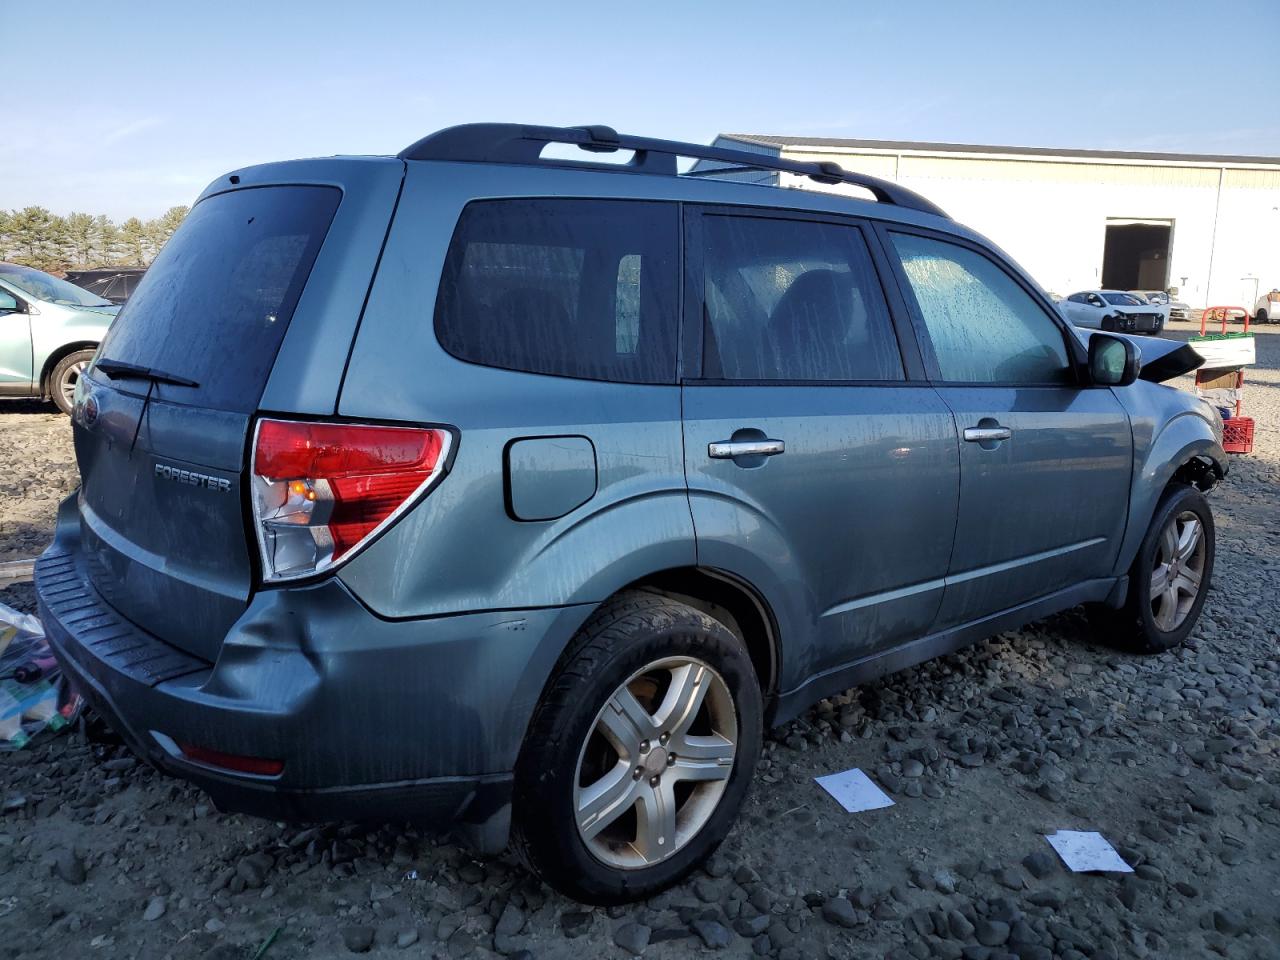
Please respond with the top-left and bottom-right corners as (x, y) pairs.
(100, 187), (342, 413)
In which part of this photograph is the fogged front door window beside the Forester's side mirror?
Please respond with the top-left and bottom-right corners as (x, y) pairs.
(890, 233), (1073, 384)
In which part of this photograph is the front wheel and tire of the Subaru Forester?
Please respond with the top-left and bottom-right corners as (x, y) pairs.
(1089, 484), (1216, 654)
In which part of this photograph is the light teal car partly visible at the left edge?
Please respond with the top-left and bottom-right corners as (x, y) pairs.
(0, 264), (120, 413)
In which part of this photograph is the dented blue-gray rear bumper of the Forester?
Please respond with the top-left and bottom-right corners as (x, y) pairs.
(36, 500), (589, 840)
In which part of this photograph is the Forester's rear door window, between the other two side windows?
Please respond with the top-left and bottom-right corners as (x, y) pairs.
(703, 215), (902, 380)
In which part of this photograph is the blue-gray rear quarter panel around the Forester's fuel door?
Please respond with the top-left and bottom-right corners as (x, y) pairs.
(338, 164), (696, 617)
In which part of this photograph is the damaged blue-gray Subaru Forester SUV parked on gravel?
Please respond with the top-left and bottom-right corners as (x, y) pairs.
(37, 124), (1226, 902)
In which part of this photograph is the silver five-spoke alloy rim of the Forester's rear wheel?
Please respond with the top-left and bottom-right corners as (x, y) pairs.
(573, 657), (739, 869)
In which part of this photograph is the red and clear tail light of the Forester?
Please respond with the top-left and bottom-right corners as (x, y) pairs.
(251, 420), (451, 582)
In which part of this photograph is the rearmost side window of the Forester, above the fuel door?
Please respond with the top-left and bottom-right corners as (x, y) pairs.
(435, 198), (680, 384)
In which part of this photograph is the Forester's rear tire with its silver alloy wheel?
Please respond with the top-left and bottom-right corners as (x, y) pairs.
(512, 593), (763, 905)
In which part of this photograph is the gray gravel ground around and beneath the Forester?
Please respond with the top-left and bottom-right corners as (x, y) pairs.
(0, 324), (1280, 960)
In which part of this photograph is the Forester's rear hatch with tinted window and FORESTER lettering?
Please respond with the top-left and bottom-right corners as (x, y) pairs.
(74, 164), (399, 660)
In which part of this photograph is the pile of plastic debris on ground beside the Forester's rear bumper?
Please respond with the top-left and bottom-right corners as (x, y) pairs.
(0, 603), (83, 750)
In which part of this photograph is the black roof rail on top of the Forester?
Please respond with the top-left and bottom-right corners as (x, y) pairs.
(398, 123), (946, 218)
